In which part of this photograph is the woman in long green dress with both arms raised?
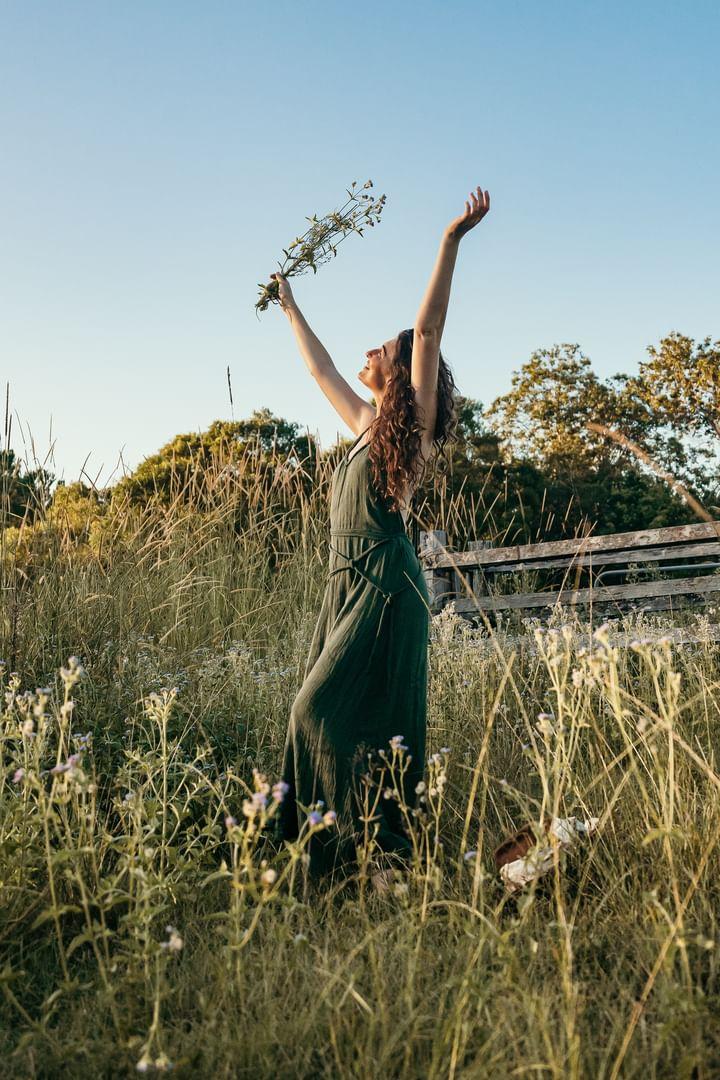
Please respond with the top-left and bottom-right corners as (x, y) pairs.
(271, 187), (490, 891)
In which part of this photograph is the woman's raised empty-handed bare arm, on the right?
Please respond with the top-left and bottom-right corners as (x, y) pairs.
(410, 188), (490, 440)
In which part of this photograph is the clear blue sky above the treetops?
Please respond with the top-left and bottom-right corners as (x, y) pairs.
(0, 0), (720, 484)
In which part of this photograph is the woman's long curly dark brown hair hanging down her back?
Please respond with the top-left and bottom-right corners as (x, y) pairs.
(368, 329), (458, 543)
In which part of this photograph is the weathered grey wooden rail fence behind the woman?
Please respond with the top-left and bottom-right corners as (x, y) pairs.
(419, 522), (720, 617)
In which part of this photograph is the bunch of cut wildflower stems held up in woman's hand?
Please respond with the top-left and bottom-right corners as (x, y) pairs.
(255, 180), (386, 311)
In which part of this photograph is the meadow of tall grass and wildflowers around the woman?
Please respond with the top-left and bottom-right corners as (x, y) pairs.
(0, 442), (720, 1080)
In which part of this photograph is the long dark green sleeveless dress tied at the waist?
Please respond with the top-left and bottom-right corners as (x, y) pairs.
(279, 428), (430, 876)
